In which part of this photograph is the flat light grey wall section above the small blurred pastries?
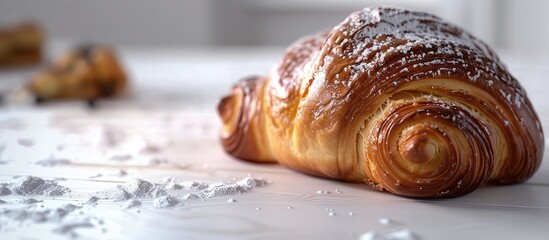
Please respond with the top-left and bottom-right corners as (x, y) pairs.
(0, 0), (213, 45)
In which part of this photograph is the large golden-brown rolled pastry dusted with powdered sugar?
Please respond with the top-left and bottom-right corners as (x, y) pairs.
(218, 8), (544, 197)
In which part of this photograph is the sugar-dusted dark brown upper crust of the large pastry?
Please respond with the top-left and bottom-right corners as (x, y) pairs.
(276, 7), (526, 131)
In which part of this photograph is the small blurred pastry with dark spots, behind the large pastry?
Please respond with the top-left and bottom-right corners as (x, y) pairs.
(28, 46), (127, 101)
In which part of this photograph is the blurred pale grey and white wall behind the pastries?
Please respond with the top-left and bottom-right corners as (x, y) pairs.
(0, 0), (549, 55)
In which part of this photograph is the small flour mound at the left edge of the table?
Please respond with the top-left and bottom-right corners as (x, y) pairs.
(0, 176), (71, 196)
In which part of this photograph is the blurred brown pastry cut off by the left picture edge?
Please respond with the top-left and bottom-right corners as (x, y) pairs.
(0, 22), (44, 67)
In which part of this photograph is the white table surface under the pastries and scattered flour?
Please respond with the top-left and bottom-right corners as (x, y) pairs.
(0, 44), (549, 239)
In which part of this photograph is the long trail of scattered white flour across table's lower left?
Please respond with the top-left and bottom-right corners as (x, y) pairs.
(0, 176), (268, 238)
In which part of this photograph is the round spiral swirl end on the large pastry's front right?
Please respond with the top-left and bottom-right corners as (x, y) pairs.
(359, 97), (494, 197)
